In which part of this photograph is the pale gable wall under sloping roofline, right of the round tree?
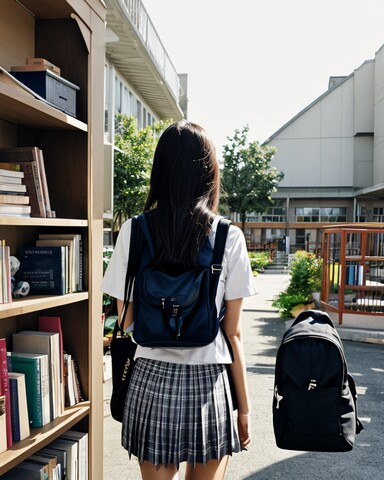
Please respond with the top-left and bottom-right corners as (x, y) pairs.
(270, 77), (353, 187)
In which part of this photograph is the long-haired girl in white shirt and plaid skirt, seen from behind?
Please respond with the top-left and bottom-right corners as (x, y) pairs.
(103, 120), (256, 480)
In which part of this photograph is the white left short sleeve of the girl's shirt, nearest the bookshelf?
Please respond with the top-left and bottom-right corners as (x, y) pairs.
(101, 220), (132, 300)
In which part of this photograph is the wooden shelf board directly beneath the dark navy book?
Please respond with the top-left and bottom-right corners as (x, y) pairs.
(0, 292), (89, 319)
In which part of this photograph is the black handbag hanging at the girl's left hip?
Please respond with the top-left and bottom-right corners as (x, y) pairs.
(110, 321), (137, 422)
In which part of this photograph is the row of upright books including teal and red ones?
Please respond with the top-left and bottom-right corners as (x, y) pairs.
(0, 316), (84, 458)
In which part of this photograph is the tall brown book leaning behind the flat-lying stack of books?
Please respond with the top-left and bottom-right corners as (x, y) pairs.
(0, 147), (46, 218)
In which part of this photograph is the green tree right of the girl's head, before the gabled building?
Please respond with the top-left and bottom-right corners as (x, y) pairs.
(222, 126), (284, 230)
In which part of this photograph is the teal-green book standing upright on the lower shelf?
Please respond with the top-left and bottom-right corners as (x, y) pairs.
(8, 352), (51, 428)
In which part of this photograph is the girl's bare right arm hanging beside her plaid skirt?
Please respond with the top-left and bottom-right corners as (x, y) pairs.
(223, 298), (251, 448)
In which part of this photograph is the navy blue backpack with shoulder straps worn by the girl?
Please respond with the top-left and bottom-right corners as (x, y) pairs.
(126, 213), (230, 347)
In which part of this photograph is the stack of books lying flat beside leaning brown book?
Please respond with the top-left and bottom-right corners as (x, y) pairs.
(0, 163), (31, 217)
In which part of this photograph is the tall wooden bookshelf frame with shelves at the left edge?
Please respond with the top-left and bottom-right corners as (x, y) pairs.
(0, 0), (106, 480)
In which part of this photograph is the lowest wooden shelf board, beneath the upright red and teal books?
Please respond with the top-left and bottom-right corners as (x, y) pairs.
(0, 401), (90, 475)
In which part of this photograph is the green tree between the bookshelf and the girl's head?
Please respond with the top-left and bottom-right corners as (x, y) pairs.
(113, 114), (170, 230)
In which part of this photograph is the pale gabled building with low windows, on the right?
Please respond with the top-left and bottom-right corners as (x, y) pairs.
(245, 46), (384, 253)
